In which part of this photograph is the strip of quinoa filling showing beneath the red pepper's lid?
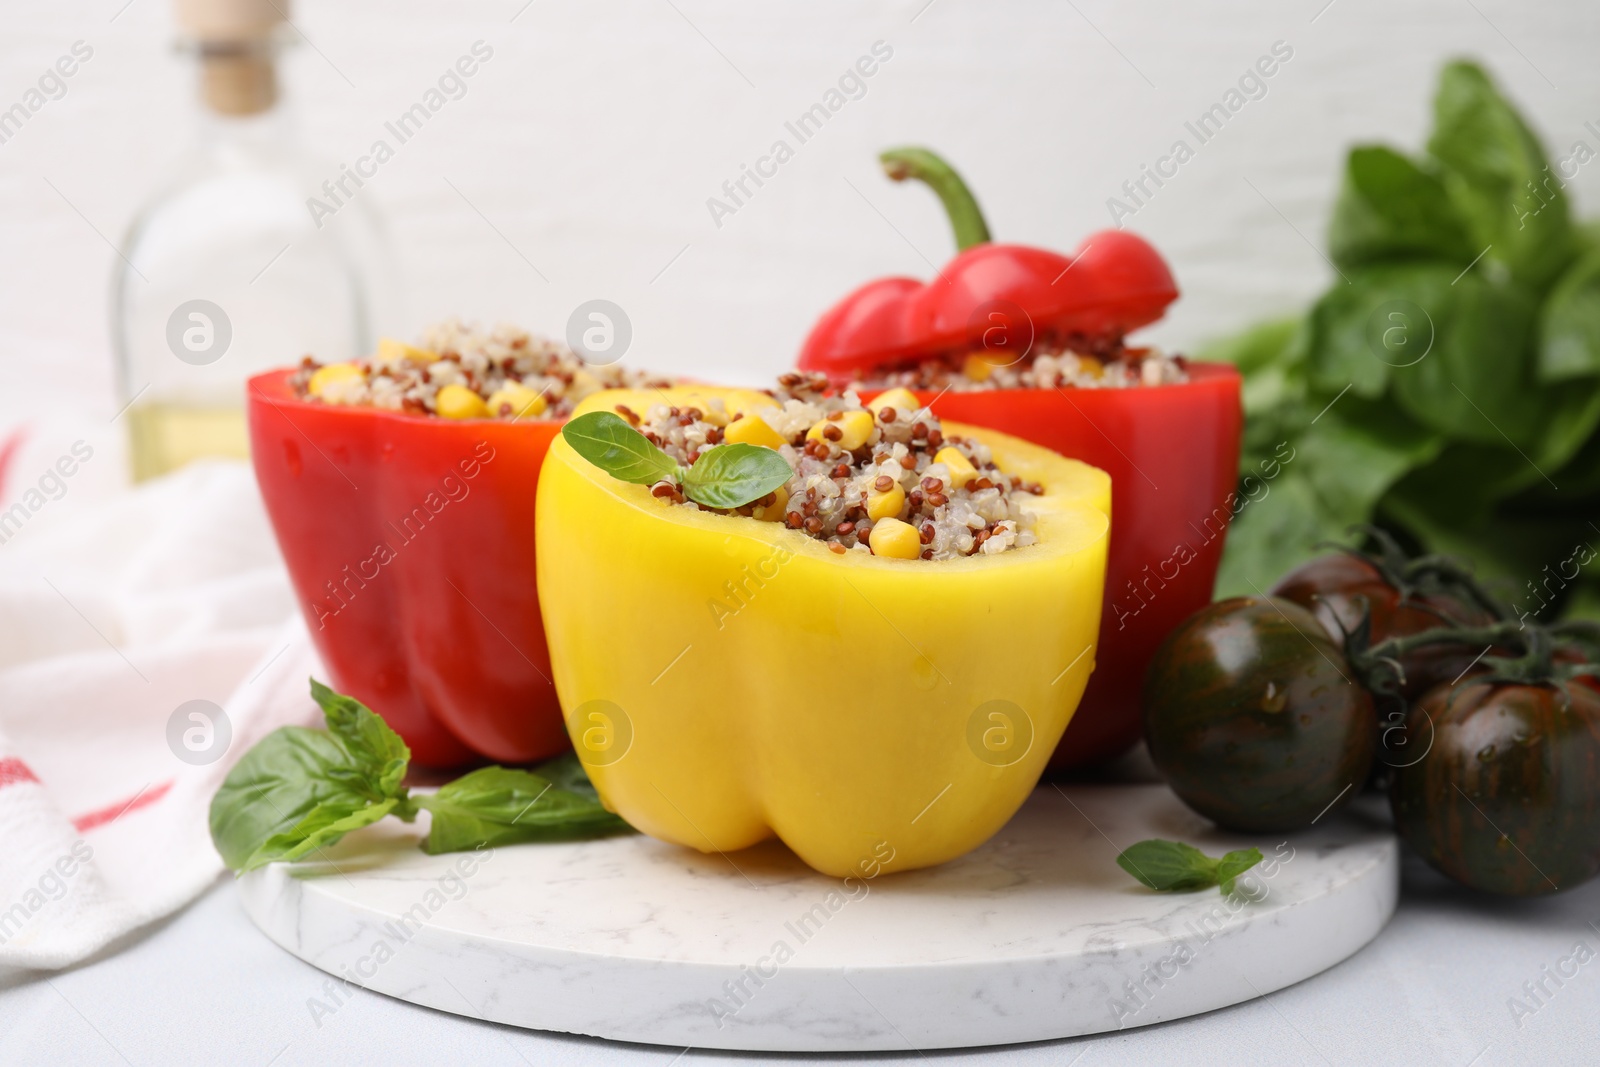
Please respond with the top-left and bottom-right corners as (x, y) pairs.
(858, 338), (1189, 392)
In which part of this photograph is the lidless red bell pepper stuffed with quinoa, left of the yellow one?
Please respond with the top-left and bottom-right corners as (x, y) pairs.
(248, 323), (668, 766)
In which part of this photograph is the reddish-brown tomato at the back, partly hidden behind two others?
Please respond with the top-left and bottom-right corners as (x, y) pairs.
(1267, 552), (1493, 704)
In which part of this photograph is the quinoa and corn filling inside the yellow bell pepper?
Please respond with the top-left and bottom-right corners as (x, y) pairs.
(616, 374), (1043, 560)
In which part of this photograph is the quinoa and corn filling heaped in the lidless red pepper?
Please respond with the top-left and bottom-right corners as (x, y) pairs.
(290, 318), (669, 419)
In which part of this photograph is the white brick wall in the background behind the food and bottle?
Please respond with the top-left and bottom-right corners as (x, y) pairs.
(0, 0), (1600, 476)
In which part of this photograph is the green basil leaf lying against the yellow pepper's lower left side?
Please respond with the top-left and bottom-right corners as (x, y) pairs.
(416, 766), (629, 856)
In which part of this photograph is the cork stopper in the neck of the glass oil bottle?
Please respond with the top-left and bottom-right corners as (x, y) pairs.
(173, 0), (290, 115)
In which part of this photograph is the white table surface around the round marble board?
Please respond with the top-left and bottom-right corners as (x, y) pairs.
(0, 831), (1600, 1067)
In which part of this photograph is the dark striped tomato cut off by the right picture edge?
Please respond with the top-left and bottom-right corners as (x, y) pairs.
(1389, 681), (1600, 896)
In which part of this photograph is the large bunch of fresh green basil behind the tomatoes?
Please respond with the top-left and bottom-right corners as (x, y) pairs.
(1203, 61), (1600, 616)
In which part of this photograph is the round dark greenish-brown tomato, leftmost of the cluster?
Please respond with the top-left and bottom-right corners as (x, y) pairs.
(1142, 597), (1378, 830)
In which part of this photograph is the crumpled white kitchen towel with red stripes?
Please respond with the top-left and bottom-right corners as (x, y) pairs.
(0, 462), (320, 968)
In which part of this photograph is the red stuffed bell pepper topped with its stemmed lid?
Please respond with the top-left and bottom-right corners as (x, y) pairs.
(798, 149), (1243, 768)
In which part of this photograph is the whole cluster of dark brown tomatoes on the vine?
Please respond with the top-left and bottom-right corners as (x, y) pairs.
(1142, 531), (1600, 896)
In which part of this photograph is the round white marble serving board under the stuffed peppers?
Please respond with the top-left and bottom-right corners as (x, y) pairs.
(238, 784), (1400, 1051)
